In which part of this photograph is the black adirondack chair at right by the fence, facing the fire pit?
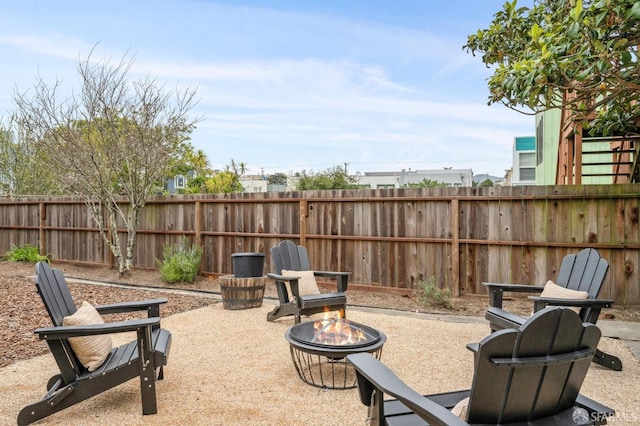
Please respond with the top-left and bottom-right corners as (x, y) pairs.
(482, 248), (622, 371)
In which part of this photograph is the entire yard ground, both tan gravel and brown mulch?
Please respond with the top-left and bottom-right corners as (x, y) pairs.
(0, 263), (640, 426)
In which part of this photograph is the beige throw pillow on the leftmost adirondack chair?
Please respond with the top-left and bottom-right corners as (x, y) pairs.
(62, 301), (113, 371)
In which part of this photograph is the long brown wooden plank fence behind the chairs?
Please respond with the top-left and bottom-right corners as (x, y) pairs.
(0, 184), (640, 304)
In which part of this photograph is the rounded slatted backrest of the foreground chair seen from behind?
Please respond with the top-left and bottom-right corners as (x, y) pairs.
(468, 307), (600, 424)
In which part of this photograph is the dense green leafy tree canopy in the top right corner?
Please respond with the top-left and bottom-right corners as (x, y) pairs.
(463, 0), (640, 136)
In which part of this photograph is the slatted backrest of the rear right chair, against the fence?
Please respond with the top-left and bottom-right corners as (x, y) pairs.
(556, 248), (609, 299)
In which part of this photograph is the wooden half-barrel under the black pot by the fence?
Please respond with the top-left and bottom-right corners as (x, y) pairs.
(220, 275), (267, 310)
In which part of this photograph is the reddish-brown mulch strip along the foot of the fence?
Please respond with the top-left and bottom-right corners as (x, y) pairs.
(0, 262), (640, 368)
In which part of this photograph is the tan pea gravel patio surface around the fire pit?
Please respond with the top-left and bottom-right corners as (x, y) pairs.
(0, 303), (640, 425)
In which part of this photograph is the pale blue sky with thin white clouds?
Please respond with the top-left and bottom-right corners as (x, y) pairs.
(0, 0), (535, 176)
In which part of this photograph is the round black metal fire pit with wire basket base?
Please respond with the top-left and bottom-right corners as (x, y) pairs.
(284, 321), (387, 389)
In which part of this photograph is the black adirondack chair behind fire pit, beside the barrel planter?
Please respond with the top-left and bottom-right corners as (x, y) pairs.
(267, 240), (349, 324)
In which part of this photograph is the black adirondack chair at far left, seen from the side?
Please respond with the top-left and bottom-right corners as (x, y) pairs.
(18, 262), (171, 425)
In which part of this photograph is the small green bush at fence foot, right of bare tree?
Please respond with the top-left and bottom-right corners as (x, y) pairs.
(156, 237), (203, 283)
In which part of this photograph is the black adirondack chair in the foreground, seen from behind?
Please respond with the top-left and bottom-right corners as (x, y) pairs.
(347, 307), (614, 426)
